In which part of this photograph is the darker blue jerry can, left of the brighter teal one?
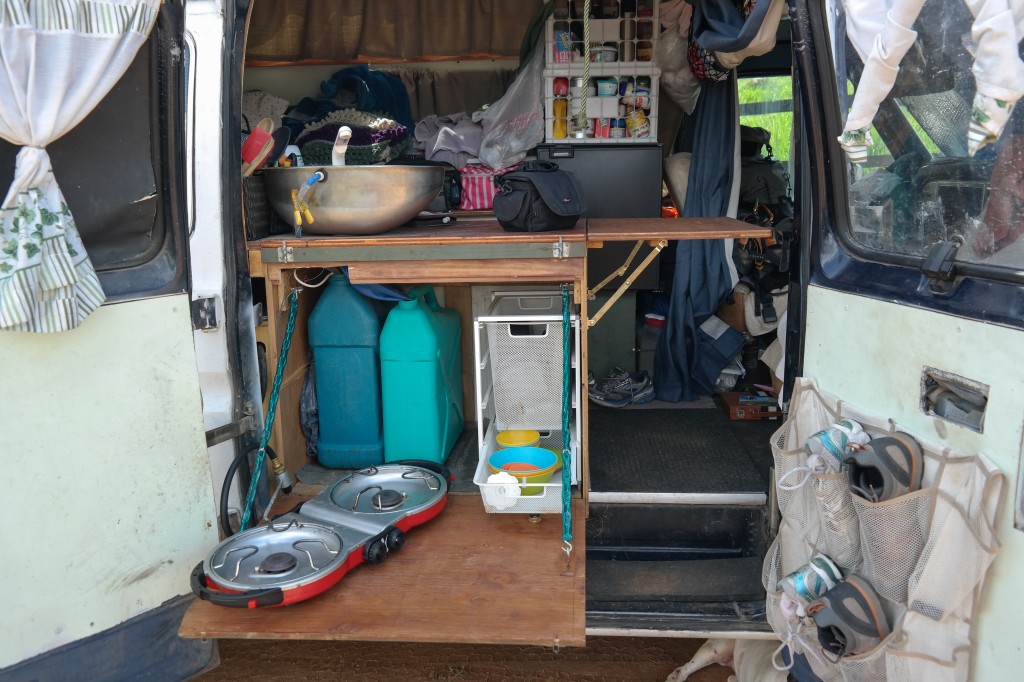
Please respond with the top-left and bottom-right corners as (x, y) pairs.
(308, 274), (384, 469)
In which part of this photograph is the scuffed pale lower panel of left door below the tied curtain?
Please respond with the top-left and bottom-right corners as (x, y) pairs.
(0, 294), (217, 669)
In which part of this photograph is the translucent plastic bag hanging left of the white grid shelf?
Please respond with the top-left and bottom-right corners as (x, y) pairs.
(473, 40), (544, 170)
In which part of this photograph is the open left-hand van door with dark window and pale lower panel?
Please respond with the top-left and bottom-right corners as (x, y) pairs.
(0, 0), (234, 680)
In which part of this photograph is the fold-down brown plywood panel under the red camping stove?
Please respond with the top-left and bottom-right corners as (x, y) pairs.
(179, 495), (586, 646)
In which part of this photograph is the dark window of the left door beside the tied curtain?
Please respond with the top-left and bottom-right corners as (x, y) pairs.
(0, 17), (187, 302)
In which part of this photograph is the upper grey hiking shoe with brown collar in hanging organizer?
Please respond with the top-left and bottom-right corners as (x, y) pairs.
(846, 432), (925, 502)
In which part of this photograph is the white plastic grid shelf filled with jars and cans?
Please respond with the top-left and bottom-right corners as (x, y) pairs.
(544, 0), (662, 144)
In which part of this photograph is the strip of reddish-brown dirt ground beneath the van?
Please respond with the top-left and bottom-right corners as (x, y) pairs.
(196, 637), (732, 682)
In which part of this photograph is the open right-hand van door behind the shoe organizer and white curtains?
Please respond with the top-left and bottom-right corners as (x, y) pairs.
(782, 0), (1024, 680)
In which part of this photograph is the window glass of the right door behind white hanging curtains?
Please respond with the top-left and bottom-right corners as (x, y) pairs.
(829, 0), (1024, 267)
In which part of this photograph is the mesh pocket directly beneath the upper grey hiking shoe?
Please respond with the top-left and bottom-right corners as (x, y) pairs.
(851, 488), (934, 603)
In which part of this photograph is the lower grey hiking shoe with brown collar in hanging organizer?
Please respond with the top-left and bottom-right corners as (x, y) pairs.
(807, 573), (890, 656)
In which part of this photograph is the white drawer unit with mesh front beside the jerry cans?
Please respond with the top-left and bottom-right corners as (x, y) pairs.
(473, 291), (582, 514)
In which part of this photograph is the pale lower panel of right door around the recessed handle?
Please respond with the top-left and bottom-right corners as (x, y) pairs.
(804, 287), (1024, 680)
